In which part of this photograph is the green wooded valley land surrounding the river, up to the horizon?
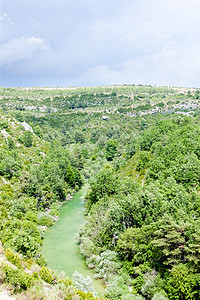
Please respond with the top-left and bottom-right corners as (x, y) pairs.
(0, 85), (200, 300)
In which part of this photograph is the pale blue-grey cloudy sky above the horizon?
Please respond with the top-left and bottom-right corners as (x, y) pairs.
(0, 0), (200, 88)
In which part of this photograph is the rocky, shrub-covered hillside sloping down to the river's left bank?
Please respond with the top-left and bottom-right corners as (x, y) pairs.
(0, 112), (95, 299)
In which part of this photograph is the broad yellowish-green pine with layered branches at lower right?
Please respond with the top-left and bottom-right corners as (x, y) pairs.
(116, 215), (199, 272)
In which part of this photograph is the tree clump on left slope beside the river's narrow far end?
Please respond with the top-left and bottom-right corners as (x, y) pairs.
(26, 142), (82, 208)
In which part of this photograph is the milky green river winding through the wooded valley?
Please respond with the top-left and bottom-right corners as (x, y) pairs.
(42, 187), (104, 296)
